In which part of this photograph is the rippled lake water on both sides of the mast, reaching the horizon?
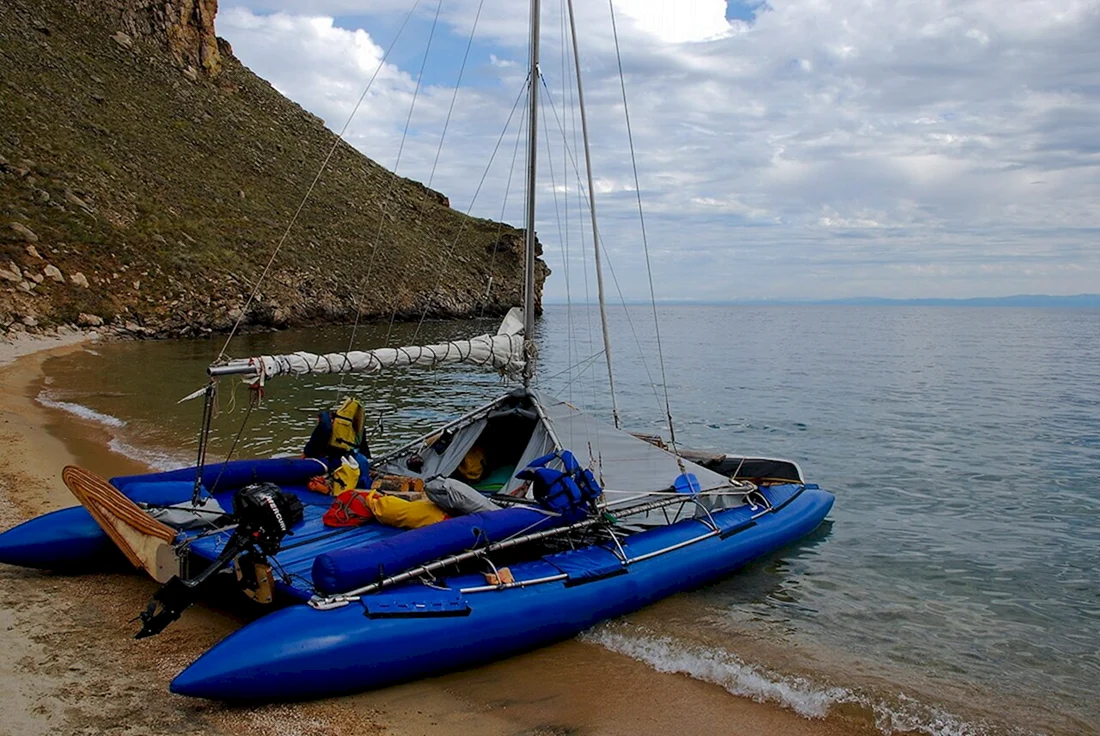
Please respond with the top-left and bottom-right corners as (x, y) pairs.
(40, 306), (1100, 734)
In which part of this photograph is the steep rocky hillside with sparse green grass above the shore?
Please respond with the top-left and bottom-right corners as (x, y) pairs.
(0, 0), (549, 336)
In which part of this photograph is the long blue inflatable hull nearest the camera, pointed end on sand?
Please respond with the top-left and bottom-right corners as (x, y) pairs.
(172, 486), (834, 701)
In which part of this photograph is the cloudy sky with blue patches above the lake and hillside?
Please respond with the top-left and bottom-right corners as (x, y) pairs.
(217, 0), (1100, 301)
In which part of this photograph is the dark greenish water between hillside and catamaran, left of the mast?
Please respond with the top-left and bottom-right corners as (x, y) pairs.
(43, 320), (501, 461)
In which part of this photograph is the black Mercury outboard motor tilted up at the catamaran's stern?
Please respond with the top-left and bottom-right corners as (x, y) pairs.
(134, 483), (305, 639)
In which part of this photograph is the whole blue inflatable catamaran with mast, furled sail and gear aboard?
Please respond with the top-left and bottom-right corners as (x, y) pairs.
(0, 0), (834, 701)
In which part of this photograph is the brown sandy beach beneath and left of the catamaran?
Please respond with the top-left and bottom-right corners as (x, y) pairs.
(0, 334), (876, 736)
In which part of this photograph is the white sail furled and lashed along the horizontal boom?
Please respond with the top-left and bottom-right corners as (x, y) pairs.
(209, 309), (524, 381)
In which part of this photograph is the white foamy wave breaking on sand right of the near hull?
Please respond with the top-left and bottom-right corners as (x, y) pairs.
(581, 623), (1007, 736)
